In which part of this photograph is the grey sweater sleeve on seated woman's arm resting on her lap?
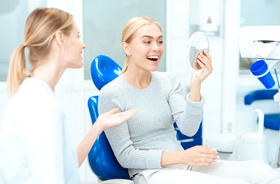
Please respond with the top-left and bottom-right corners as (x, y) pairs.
(98, 81), (163, 169)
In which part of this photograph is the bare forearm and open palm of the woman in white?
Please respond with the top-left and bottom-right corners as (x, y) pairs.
(77, 109), (138, 166)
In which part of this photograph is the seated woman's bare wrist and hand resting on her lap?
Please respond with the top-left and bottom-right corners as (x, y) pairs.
(161, 146), (219, 167)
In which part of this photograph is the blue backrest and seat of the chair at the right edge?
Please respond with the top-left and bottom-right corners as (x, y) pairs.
(244, 89), (280, 130)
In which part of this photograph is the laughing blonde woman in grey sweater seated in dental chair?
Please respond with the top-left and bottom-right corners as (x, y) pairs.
(99, 17), (280, 184)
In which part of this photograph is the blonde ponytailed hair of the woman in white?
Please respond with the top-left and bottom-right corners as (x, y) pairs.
(7, 8), (74, 95)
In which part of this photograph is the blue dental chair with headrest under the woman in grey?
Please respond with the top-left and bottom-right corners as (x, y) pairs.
(88, 55), (202, 184)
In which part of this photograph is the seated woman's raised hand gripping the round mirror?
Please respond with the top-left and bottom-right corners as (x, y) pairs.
(192, 50), (213, 83)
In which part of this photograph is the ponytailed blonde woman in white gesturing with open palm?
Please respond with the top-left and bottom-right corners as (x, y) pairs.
(0, 8), (137, 184)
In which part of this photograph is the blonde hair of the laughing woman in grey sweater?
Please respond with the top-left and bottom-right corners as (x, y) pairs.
(121, 17), (162, 73)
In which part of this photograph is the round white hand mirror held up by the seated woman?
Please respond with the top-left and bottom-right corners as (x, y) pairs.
(186, 32), (209, 75)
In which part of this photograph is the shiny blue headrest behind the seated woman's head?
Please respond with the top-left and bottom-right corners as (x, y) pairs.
(90, 55), (122, 90)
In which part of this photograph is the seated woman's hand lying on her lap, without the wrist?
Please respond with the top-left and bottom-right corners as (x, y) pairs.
(184, 146), (219, 166)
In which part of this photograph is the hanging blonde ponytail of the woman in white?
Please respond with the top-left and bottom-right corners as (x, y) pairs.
(7, 44), (30, 95)
